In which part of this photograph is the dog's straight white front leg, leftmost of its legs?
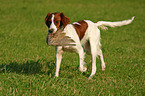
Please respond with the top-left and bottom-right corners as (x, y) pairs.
(55, 46), (63, 77)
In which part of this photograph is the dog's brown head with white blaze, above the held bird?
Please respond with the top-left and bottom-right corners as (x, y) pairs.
(45, 12), (70, 33)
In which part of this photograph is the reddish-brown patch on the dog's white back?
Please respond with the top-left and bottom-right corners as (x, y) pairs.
(73, 20), (88, 40)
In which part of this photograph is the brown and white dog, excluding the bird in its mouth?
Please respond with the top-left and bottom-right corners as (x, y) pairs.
(45, 12), (134, 78)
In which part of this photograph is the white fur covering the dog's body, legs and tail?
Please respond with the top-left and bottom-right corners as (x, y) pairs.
(52, 17), (134, 78)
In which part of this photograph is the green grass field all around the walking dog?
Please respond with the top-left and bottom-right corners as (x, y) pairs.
(0, 0), (145, 96)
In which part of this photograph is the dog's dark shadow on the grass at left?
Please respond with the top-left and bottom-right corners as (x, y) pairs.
(0, 60), (55, 75)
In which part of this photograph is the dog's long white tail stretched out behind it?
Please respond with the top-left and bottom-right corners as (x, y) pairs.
(95, 16), (135, 30)
